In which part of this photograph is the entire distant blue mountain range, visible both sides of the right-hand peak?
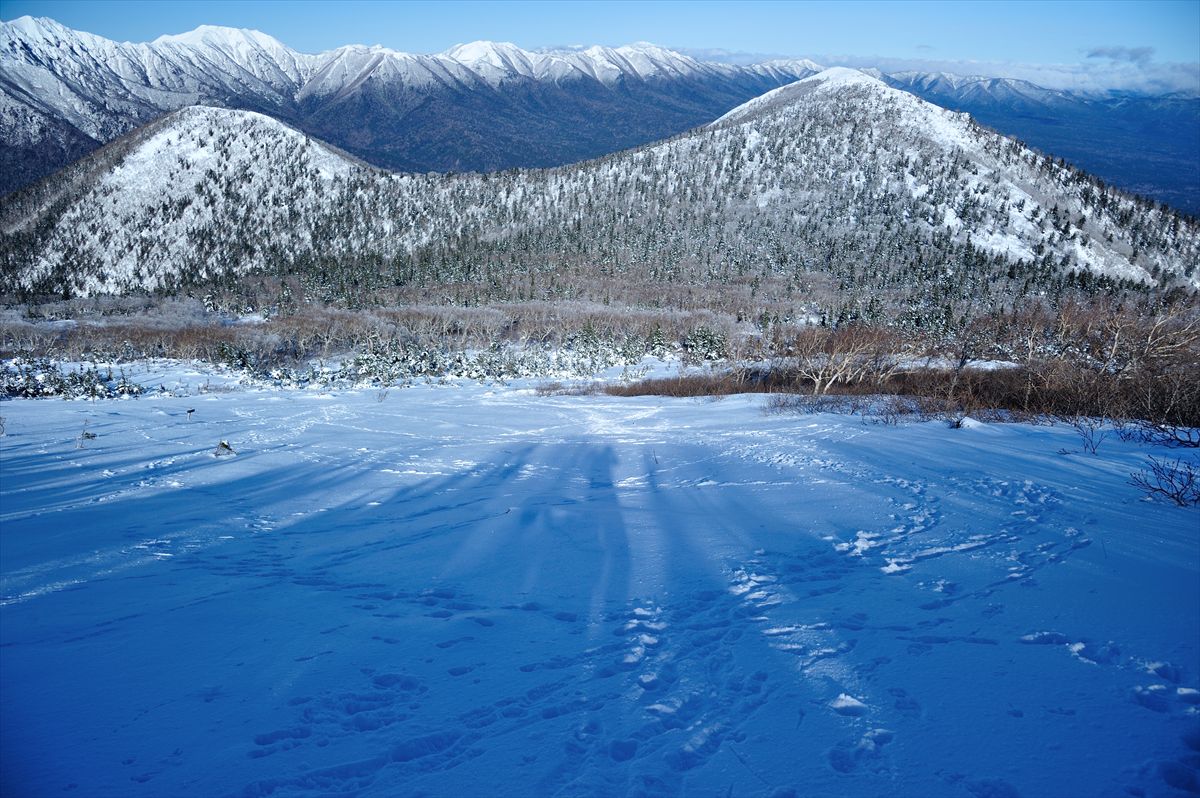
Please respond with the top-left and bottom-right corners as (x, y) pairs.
(0, 17), (1200, 214)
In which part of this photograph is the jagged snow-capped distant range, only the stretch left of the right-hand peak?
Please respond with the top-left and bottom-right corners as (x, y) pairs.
(0, 17), (818, 191)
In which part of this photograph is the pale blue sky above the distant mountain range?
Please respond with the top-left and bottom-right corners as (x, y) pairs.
(2, 0), (1200, 88)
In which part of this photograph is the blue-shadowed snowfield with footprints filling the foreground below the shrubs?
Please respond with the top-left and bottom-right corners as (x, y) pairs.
(0, 373), (1200, 798)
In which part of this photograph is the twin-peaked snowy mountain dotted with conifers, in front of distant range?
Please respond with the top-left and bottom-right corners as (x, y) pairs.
(0, 68), (1200, 312)
